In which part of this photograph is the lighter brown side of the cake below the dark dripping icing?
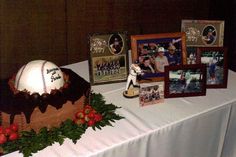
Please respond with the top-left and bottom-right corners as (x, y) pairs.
(1, 96), (86, 132)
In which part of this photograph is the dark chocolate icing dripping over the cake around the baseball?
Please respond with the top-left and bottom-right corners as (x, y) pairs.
(0, 68), (90, 123)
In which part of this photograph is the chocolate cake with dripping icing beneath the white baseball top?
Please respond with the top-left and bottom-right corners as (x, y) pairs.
(0, 60), (90, 132)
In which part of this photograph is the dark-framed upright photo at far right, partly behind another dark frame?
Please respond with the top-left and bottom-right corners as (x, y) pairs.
(197, 47), (228, 88)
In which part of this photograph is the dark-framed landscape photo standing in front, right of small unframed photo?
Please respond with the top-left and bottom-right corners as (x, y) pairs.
(164, 64), (206, 98)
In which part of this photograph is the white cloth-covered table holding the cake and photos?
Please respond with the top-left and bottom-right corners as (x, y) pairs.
(5, 61), (236, 157)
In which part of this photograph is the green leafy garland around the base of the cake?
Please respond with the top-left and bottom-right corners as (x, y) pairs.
(0, 93), (123, 157)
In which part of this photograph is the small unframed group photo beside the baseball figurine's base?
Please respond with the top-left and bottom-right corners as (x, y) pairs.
(139, 81), (164, 106)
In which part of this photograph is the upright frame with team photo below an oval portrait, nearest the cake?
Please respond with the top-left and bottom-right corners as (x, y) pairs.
(89, 32), (128, 85)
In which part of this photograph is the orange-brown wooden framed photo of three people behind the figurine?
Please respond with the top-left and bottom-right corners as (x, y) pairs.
(131, 32), (186, 82)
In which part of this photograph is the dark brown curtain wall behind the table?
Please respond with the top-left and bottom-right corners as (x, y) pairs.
(0, 0), (236, 78)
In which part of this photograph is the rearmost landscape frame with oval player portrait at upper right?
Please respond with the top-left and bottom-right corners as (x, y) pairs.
(181, 20), (224, 47)
